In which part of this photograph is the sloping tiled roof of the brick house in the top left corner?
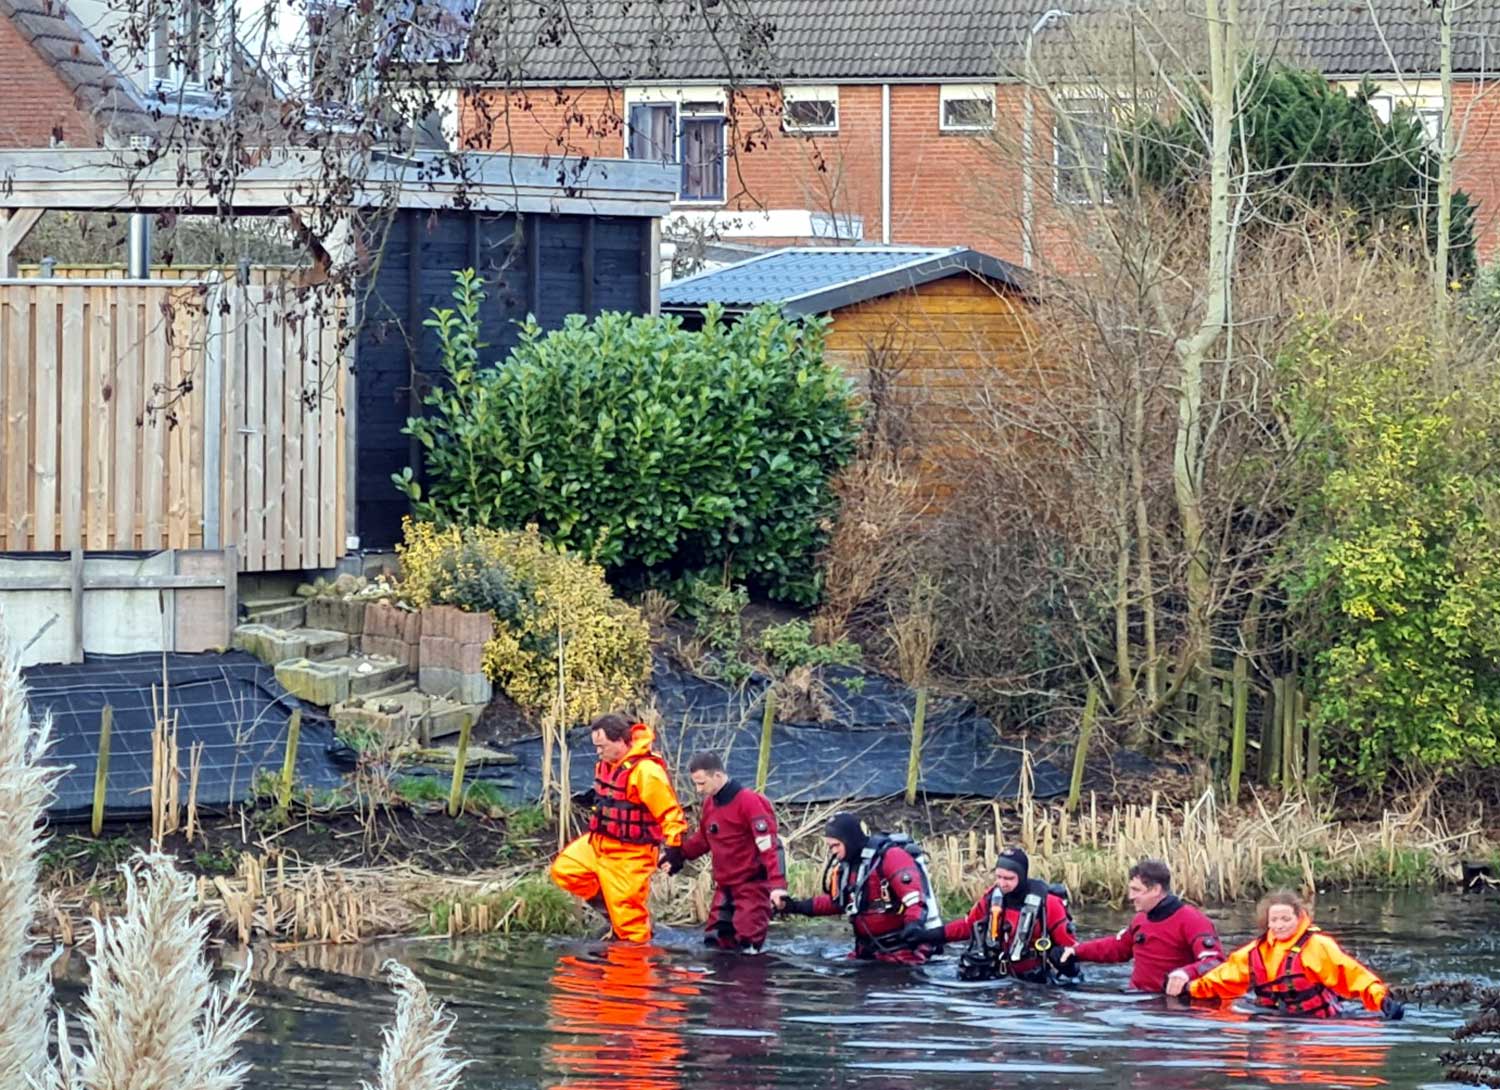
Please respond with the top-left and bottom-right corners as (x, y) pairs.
(0, 0), (158, 135)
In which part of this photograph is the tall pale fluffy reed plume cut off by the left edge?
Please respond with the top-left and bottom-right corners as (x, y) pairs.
(0, 625), (59, 1087)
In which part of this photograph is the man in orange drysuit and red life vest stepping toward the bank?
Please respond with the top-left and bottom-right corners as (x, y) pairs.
(552, 715), (687, 943)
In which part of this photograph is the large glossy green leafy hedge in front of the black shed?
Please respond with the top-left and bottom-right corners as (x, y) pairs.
(396, 271), (860, 603)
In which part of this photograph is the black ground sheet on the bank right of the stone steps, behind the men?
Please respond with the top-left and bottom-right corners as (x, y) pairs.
(417, 658), (1068, 802)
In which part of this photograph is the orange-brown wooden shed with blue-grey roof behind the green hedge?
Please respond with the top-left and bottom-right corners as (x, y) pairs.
(662, 246), (1031, 495)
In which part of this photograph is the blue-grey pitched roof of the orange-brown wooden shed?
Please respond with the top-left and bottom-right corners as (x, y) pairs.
(662, 246), (1026, 315)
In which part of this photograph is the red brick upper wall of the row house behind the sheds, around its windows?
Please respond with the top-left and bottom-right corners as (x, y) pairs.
(462, 82), (1500, 273)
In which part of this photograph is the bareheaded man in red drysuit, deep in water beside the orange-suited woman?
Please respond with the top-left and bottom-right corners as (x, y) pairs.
(1065, 859), (1224, 993)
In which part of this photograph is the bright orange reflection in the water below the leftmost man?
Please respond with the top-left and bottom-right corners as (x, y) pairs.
(548, 943), (699, 1090)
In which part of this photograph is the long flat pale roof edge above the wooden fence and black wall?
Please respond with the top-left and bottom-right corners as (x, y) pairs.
(0, 148), (677, 217)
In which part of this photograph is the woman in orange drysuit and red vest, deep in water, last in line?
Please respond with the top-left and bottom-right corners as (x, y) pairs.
(1167, 891), (1406, 1020)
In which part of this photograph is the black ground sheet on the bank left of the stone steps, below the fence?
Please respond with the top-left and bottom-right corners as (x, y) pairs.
(23, 651), (342, 822)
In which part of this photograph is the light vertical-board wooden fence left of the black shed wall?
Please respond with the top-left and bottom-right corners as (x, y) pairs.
(0, 277), (348, 571)
